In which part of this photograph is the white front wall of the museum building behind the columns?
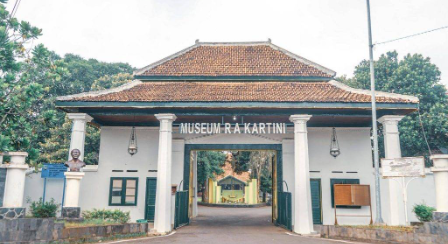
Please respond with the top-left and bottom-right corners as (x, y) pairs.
(20, 127), (435, 224)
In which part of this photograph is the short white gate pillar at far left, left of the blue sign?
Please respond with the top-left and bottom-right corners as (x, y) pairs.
(3, 152), (29, 208)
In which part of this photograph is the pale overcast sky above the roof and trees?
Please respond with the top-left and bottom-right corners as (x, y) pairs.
(8, 0), (448, 85)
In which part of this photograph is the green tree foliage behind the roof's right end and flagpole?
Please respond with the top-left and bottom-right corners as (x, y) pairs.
(338, 51), (448, 164)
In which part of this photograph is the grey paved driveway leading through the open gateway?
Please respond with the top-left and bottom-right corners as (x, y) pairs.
(107, 206), (366, 244)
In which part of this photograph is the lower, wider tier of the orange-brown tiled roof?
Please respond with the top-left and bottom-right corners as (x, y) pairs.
(59, 81), (418, 103)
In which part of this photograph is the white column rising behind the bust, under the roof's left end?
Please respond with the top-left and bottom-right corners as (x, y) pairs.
(67, 113), (92, 161)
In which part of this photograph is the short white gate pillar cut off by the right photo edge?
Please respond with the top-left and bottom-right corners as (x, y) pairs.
(431, 154), (448, 212)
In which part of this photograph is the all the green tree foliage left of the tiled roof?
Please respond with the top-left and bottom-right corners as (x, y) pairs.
(0, 1), (133, 164)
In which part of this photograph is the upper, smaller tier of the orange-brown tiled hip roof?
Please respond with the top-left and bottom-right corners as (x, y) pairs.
(135, 42), (336, 78)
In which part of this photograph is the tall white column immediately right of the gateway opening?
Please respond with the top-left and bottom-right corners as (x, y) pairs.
(289, 114), (314, 235)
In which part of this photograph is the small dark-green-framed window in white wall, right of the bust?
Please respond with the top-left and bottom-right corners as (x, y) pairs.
(109, 177), (138, 206)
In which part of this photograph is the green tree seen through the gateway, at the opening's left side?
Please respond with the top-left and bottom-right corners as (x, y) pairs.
(197, 151), (226, 201)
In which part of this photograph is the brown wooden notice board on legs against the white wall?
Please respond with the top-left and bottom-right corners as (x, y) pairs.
(334, 184), (373, 225)
